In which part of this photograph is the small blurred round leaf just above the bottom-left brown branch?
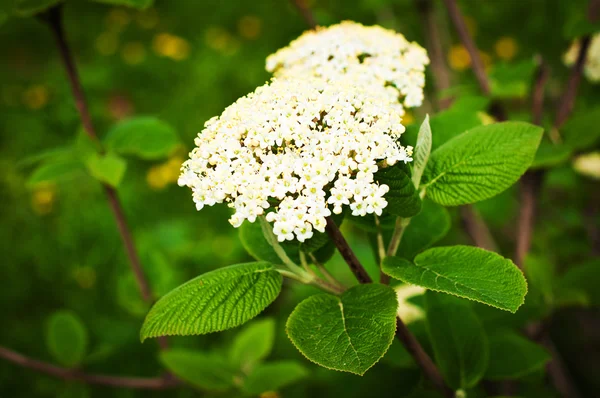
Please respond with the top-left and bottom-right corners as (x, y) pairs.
(46, 310), (88, 367)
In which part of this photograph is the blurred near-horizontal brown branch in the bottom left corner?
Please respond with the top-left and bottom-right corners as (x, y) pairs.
(0, 346), (181, 390)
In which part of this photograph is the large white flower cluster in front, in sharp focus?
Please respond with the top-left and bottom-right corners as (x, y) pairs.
(179, 76), (412, 242)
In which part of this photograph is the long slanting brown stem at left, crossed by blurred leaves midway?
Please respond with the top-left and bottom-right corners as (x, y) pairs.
(44, 6), (153, 302)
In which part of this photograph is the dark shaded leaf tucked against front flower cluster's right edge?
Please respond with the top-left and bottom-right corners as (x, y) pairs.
(375, 163), (421, 217)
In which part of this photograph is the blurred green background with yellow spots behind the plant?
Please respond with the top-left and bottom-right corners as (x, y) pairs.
(0, 0), (600, 397)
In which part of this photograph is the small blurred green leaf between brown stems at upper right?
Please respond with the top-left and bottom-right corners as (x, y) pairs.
(489, 57), (538, 98)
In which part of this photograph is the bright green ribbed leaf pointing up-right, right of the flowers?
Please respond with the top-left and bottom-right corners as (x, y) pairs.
(424, 122), (543, 206)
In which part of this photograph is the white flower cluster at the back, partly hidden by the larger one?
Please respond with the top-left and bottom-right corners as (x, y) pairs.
(266, 21), (429, 107)
